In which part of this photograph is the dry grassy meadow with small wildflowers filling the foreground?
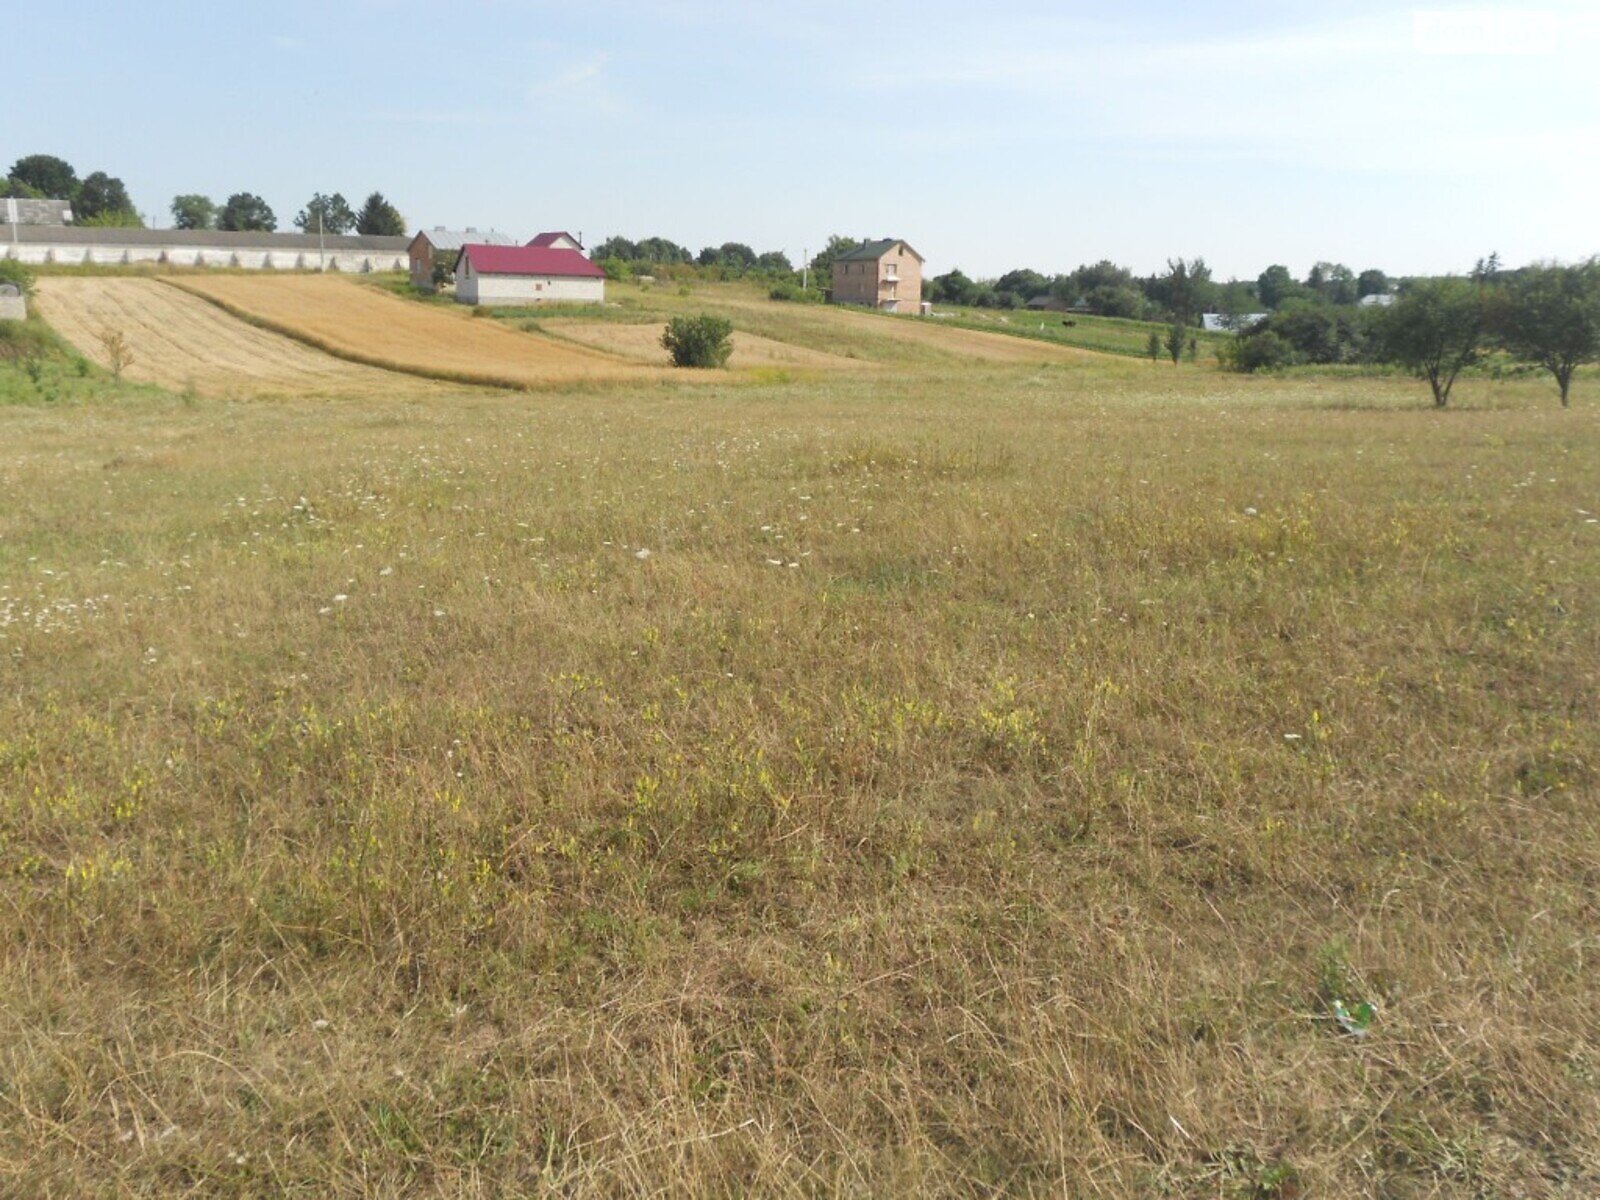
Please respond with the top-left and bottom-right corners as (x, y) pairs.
(0, 352), (1600, 1197)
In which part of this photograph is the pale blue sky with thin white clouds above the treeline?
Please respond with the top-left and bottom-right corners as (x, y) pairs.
(12, 0), (1600, 278)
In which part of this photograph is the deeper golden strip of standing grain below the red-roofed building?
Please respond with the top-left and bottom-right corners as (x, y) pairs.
(173, 275), (666, 387)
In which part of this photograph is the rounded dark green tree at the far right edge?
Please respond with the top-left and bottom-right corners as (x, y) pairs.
(1494, 258), (1600, 408)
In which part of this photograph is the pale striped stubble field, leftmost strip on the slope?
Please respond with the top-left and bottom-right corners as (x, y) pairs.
(38, 277), (418, 397)
